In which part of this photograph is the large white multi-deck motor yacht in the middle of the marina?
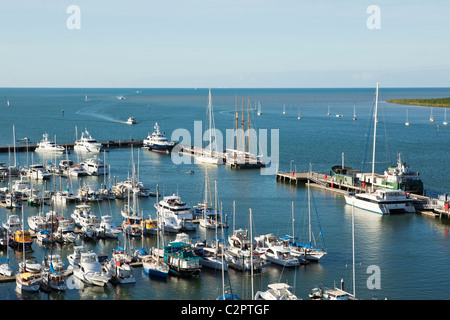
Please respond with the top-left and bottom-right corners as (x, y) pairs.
(155, 194), (195, 232)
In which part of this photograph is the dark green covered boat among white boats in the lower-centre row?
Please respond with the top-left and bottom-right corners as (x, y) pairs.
(164, 242), (201, 277)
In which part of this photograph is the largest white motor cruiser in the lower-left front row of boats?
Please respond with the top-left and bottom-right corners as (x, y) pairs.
(73, 251), (111, 287)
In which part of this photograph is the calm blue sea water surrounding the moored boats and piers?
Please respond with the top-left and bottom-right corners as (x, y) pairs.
(0, 88), (450, 300)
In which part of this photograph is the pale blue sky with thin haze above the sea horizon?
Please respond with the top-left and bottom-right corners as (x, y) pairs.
(0, 0), (450, 88)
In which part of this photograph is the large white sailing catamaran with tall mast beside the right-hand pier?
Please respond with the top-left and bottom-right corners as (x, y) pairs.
(344, 82), (415, 215)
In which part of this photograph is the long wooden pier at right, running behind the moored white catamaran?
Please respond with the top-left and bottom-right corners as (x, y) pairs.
(276, 171), (450, 217)
